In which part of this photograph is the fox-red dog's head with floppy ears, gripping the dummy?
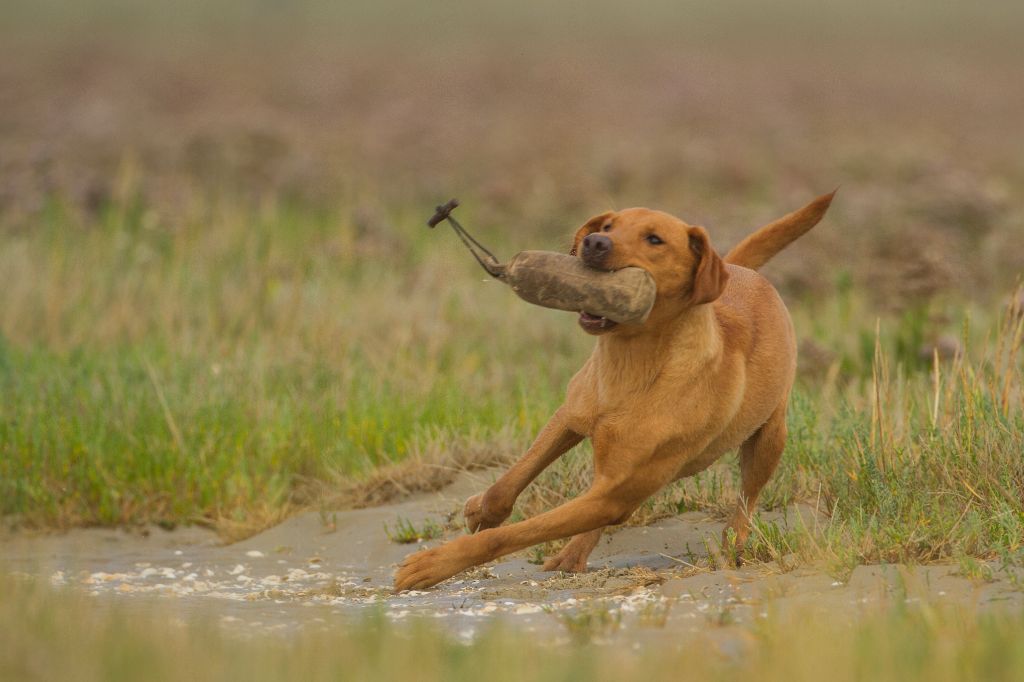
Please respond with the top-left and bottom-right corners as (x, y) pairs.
(569, 208), (729, 334)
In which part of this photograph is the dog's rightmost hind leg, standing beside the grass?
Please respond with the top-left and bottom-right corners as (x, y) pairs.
(722, 399), (787, 556)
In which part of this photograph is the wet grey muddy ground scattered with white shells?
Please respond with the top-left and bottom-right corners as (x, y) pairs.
(0, 472), (1024, 648)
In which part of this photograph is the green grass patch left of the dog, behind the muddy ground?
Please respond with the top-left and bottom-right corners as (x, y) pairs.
(0, 199), (580, 525)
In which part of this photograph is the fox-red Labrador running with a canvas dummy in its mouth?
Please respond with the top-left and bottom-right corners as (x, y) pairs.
(394, 191), (836, 592)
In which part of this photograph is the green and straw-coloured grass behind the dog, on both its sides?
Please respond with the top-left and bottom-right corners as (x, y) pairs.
(0, 195), (1024, 574)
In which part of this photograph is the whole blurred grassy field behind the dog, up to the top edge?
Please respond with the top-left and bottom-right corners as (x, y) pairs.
(0, 0), (1024, 572)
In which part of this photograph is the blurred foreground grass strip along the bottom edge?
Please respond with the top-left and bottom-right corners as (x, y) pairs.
(0, 579), (1024, 682)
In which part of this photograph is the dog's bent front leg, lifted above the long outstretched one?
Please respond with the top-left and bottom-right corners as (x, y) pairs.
(463, 408), (583, 532)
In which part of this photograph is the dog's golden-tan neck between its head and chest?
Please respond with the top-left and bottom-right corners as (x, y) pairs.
(594, 304), (722, 394)
